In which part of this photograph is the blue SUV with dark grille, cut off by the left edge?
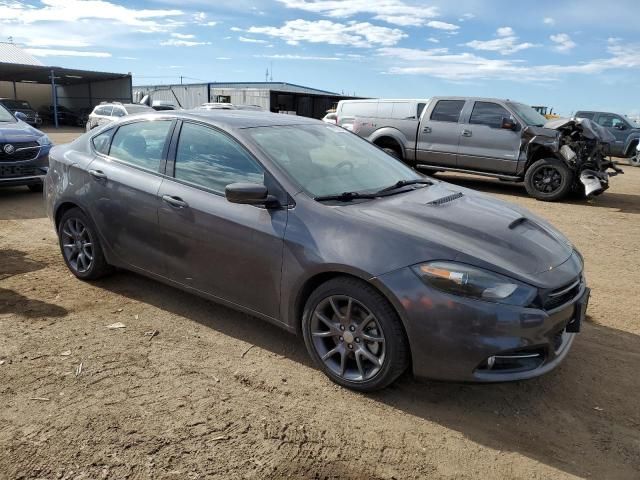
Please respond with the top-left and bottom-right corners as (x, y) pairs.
(0, 105), (51, 192)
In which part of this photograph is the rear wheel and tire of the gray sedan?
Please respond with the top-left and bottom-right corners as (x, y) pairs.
(58, 208), (112, 280)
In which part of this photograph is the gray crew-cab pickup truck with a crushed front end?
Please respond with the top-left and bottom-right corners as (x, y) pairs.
(336, 97), (618, 201)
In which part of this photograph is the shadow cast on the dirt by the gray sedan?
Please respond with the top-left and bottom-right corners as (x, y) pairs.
(98, 273), (640, 478)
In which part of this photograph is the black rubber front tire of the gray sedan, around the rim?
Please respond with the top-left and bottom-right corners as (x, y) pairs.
(302, 277), (408, 392)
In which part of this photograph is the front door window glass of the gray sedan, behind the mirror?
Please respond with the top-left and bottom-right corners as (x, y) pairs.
(174, 123), (264, 194)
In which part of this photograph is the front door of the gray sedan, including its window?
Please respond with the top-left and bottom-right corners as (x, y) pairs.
(158, 122), (287, 318)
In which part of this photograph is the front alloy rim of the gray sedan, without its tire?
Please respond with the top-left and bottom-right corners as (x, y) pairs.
(310, 295), (386, 382)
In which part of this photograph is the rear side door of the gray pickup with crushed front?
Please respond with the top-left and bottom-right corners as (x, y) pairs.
(416, 99), (465, 167)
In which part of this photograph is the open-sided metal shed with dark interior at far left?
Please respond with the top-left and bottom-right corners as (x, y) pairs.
(0, 42), (132, 126)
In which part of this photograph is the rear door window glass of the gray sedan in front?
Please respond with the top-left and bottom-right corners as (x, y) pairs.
(109, 120), (172, 172)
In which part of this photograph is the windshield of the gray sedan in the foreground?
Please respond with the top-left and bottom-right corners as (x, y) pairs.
(246, 124), (422, 197)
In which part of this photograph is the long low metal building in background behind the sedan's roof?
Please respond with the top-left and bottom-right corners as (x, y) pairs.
(133, 82), (355, 118)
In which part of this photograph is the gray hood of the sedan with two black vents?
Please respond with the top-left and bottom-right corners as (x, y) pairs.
(344, 182), (573, 283)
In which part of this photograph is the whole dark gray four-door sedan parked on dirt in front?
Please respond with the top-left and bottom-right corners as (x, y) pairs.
(45, 110), (589, 391)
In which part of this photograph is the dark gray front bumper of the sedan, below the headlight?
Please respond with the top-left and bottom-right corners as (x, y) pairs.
(374, 268), (587, 382)
